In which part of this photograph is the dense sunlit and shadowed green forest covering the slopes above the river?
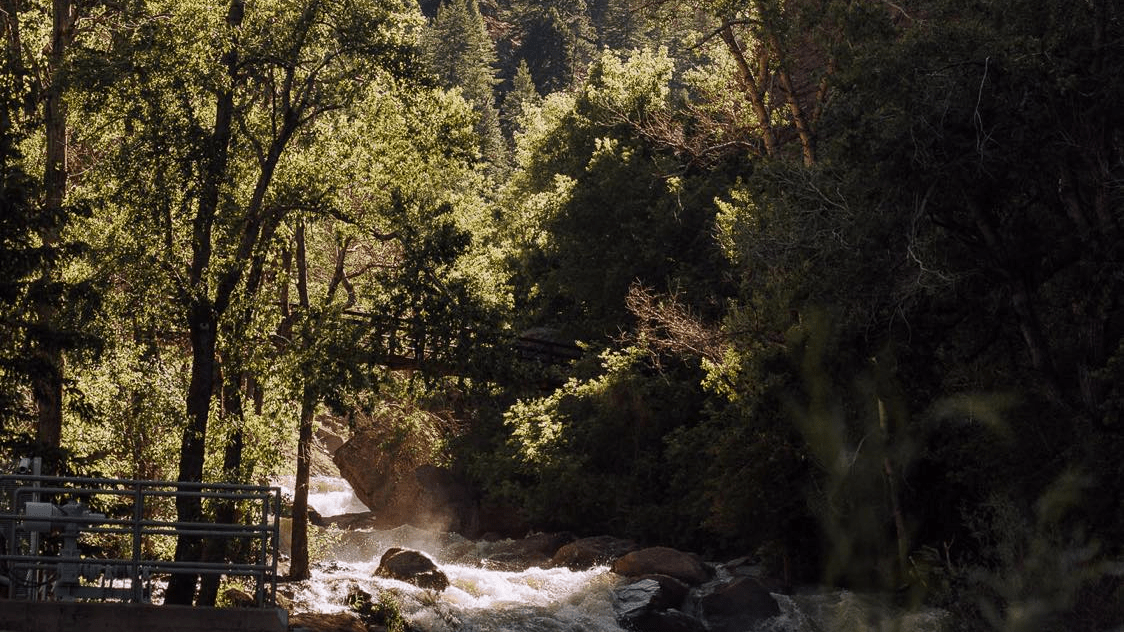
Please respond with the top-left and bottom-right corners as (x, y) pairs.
(0, 0), (1124, 630)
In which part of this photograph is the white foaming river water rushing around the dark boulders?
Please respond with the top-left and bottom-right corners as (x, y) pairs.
(281, 477), (944, 632)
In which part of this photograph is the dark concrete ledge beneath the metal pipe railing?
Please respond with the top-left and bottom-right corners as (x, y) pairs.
(0, 599), (289, 632)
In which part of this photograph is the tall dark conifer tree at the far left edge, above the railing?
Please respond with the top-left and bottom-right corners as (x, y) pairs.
(0, 0), (92, 450)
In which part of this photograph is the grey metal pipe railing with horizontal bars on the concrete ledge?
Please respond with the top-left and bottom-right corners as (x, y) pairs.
(0, 473), (281, 606)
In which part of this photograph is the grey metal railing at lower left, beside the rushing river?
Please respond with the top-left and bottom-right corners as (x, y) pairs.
(0, 473), (281, 607)
